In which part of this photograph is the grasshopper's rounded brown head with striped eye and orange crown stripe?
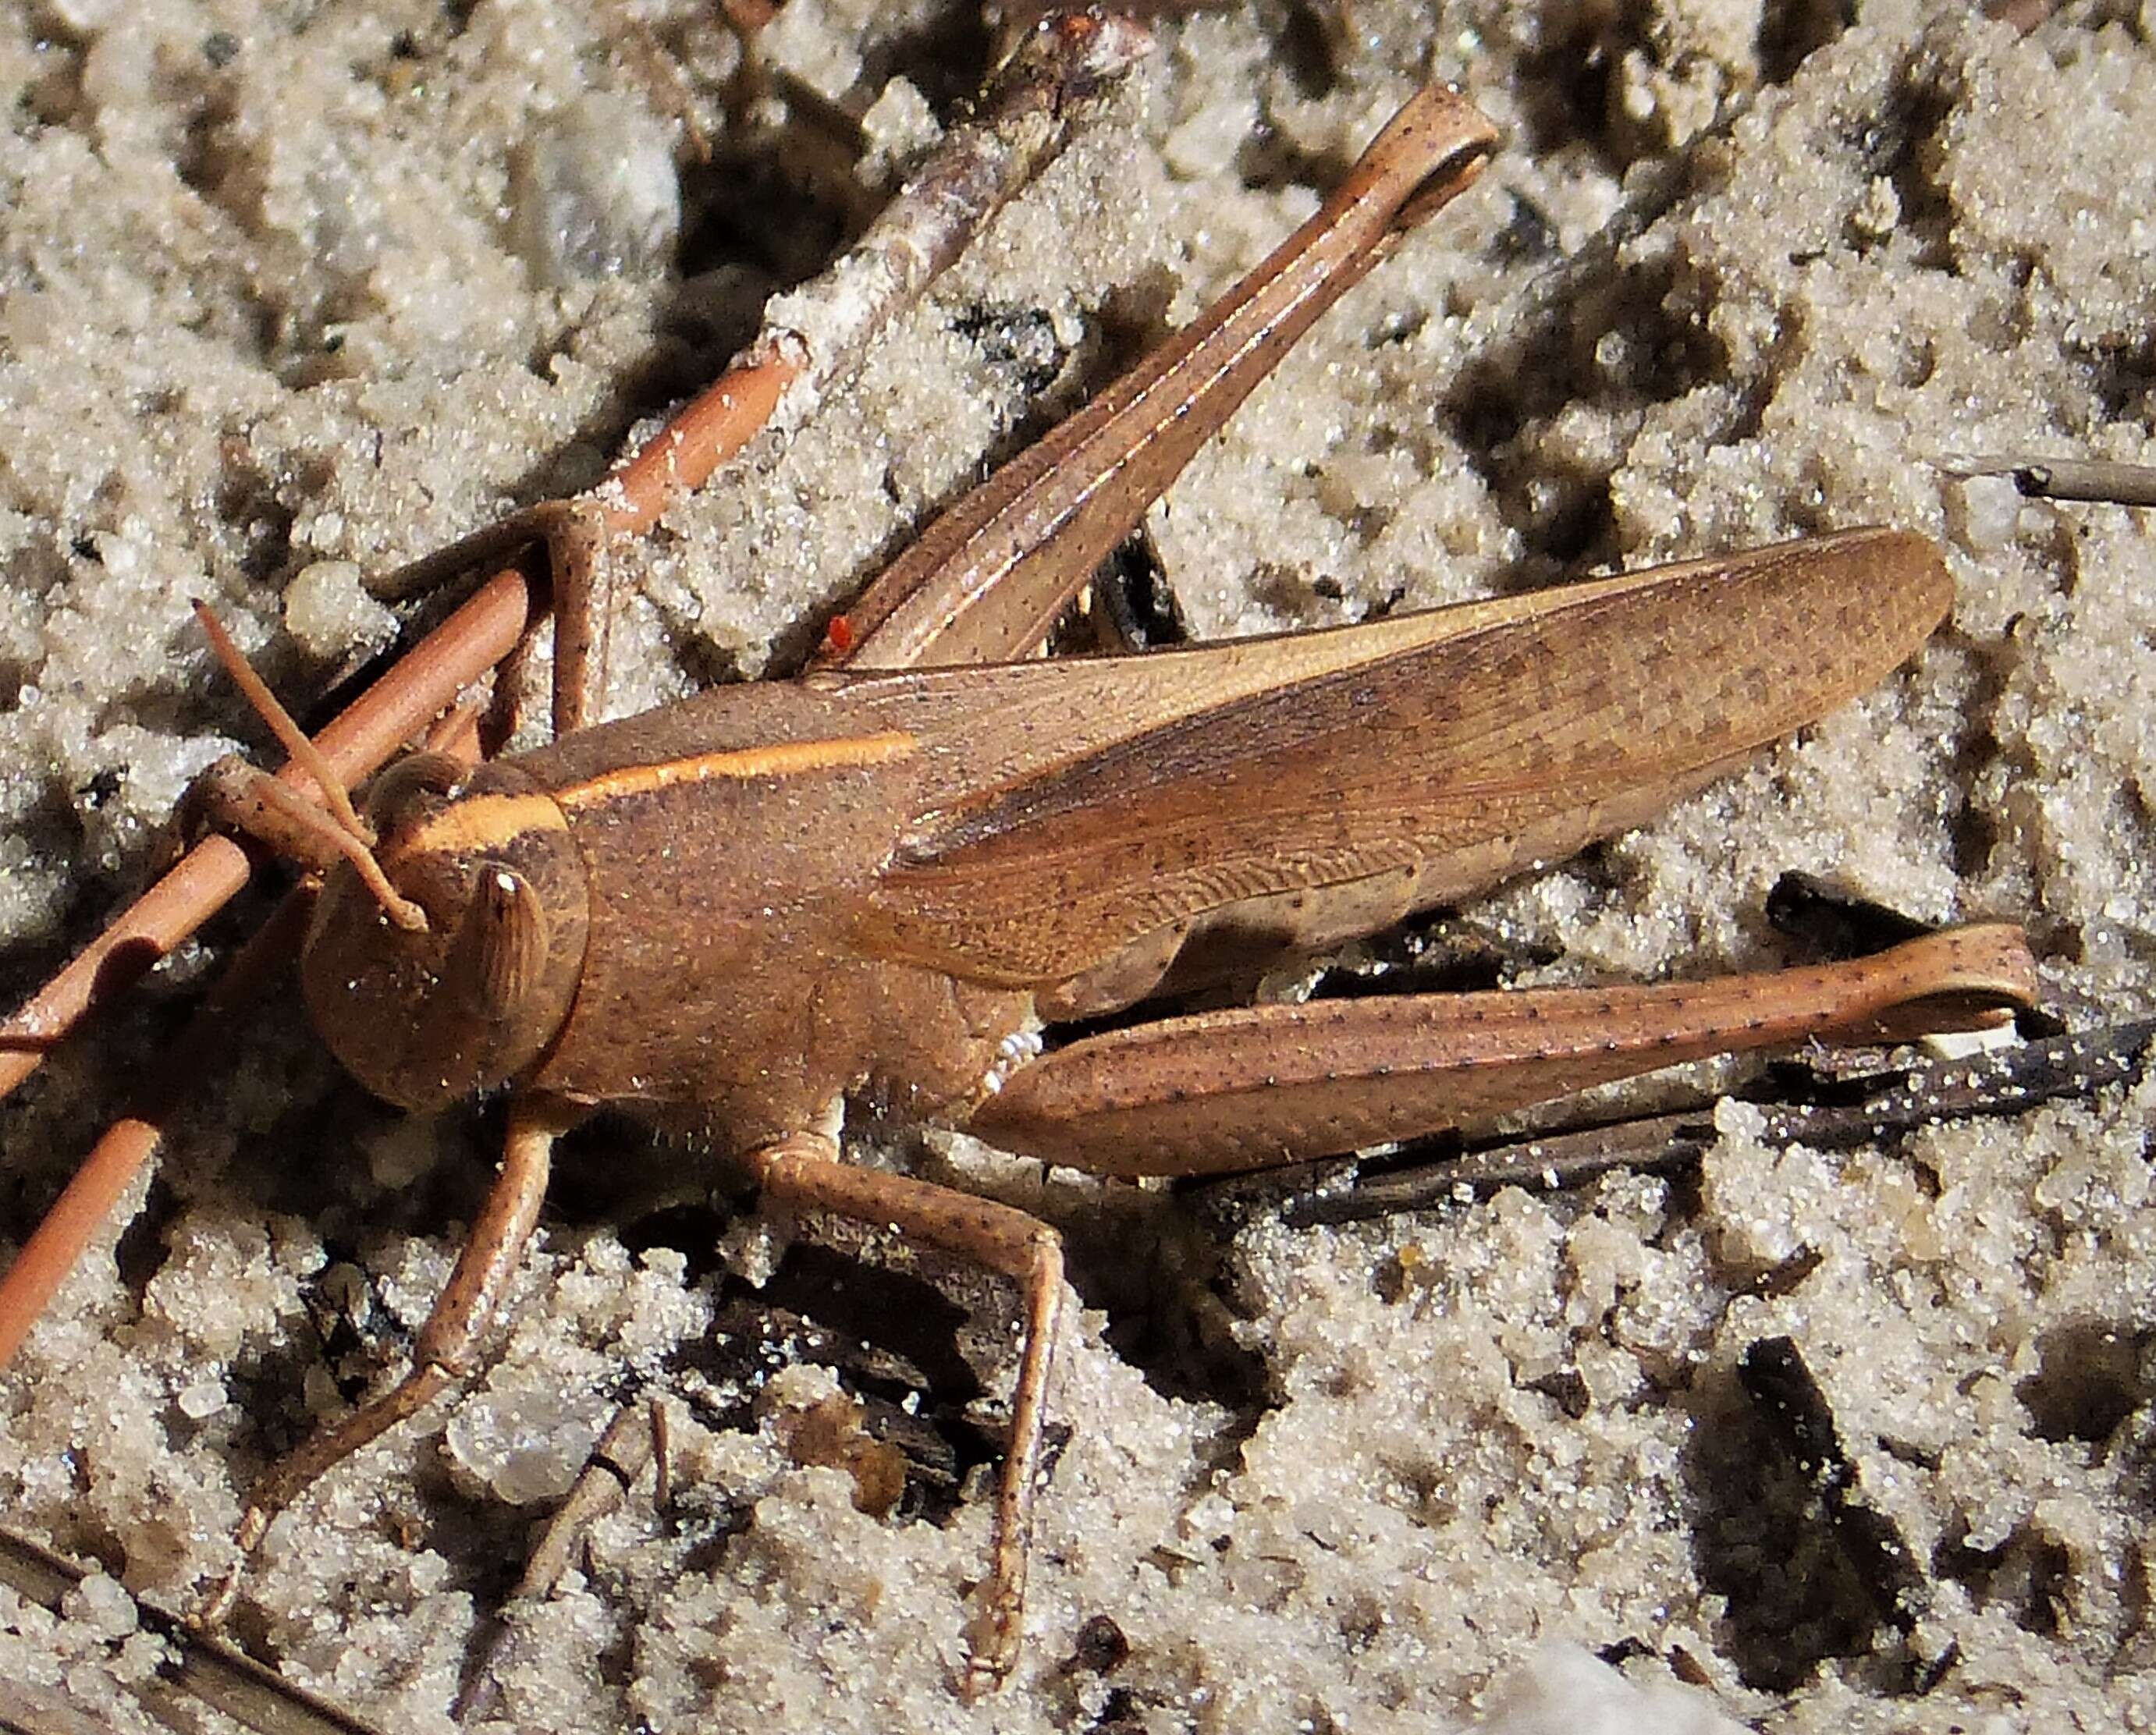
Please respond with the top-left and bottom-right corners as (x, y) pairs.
(300, 752), (588, 1110)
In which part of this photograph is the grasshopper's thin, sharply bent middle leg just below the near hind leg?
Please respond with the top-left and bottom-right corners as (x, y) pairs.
(748, 1134), (1065, 1694)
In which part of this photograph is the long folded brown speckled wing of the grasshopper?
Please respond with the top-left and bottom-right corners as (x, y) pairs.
(840, 530), (1953, 985)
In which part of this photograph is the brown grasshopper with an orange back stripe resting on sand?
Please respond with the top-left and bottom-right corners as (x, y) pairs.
(0, 61), (2031, 1687)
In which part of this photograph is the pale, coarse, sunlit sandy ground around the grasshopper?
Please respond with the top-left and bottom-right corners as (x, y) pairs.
(0, 0), (2156, 1733)
